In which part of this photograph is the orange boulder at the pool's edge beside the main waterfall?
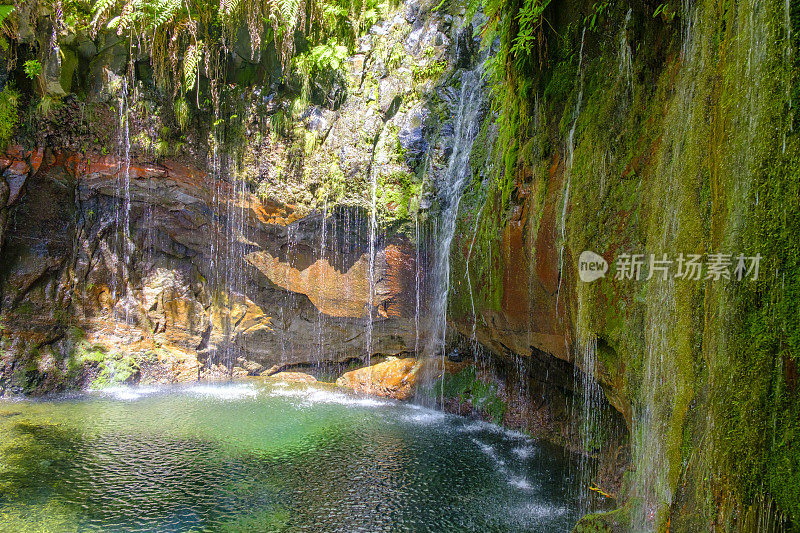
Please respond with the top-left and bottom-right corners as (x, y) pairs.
(336, 357), (422, 400)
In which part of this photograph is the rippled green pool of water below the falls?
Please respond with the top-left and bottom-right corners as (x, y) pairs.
(0, 382), (578, 532)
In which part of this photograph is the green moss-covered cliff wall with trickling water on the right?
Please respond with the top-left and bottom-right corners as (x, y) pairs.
(450, 0), (800, 531)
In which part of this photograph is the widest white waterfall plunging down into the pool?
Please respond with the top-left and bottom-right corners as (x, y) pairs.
(427, 64), (486, 394)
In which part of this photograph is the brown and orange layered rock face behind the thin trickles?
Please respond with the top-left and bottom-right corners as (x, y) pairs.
(0, 150), (414, 392)
